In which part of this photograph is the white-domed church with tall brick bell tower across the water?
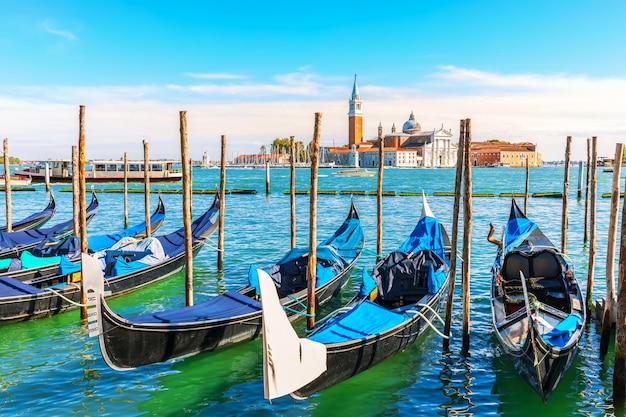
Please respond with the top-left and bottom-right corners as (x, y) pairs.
(328, 76), (457, 168)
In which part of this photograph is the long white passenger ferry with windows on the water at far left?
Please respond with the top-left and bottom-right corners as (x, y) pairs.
(15, 159), (183, 183)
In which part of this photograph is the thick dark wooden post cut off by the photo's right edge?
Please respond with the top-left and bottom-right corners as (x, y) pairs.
(613, 148), (626, 407)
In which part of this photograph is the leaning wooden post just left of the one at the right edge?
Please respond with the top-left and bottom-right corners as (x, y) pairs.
(600, 143), (624, 358)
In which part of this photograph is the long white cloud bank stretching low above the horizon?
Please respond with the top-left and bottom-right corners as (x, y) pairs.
(0, 66), (626, 160)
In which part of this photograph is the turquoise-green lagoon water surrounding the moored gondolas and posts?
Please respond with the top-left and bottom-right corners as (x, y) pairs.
(0, 167), (623, 416)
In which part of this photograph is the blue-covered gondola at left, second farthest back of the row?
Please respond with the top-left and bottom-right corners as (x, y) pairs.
(0, 192), (98, 259)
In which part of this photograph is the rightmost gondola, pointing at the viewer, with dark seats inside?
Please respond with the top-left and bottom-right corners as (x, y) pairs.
(488, 200), (586, 402)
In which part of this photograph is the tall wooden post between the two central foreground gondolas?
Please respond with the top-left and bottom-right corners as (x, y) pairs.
(307, 112), (322, 330)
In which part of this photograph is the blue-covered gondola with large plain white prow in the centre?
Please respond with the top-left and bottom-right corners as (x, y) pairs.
(259, 193), (449, 399)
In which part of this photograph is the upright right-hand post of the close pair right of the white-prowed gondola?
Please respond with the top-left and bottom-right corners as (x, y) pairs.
(462, 119), (472, 352)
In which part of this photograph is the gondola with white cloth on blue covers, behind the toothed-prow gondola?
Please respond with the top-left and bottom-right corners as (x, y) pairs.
(0, 194), (219, 324)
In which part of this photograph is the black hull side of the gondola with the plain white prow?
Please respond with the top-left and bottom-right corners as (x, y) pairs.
(290, 280), (448, 399)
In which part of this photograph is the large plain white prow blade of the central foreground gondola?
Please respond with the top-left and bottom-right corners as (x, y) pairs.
(257, 269), (326, 400)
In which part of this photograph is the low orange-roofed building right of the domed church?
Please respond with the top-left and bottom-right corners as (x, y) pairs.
(470, 140), (543, 167)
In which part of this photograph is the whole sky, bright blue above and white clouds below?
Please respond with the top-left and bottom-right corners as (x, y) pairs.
(0, 0), (626, 160)
